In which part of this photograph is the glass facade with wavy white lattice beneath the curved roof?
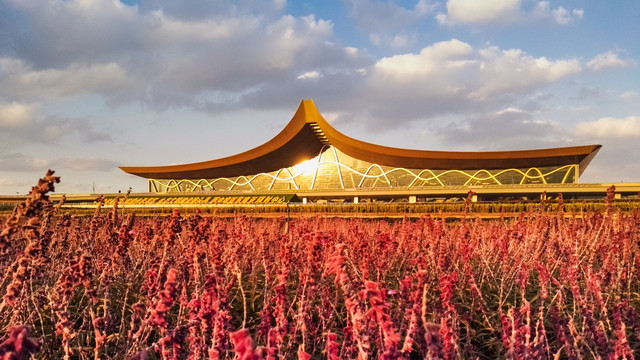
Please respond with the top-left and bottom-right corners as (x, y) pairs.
(149, 145), (578, 192)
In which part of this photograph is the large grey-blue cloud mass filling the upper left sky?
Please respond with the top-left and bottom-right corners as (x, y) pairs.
(0, 0), (370, 110)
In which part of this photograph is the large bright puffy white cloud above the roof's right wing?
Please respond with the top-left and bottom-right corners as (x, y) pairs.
(358, 39), (581, 118)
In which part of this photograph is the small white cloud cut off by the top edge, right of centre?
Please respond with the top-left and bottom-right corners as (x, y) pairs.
(437, 0), (521, 24)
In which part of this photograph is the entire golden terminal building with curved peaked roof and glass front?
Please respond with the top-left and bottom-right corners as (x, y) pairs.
(120, 100), (637, 202)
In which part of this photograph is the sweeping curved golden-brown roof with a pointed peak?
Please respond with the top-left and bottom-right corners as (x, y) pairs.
(120, 100), (601, 179)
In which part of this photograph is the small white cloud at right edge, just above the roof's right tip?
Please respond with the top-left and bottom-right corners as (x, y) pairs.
(576, 116), (640, 139)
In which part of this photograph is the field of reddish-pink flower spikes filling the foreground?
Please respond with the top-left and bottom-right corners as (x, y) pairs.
(0, 172), (640, 360)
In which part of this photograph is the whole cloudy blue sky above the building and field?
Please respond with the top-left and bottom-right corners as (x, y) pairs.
(0, 0), (640, 194)
